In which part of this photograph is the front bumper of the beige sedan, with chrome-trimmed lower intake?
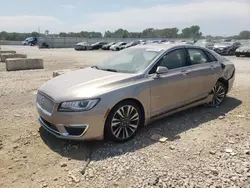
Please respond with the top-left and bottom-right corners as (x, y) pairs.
(36, 95), (106, 140)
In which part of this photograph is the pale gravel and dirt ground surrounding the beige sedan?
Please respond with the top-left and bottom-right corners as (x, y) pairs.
(0, 46), (250, 188)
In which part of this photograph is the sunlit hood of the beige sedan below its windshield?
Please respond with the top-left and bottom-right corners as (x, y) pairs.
(39, 67), (136, 102)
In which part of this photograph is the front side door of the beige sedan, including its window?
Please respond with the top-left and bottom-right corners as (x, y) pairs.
(149, 49), (190, 116)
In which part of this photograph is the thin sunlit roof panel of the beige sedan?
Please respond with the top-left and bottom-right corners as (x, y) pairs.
(132, 43), (201, 51)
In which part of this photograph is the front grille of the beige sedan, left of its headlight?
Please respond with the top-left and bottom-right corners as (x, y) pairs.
(36, 93), (54, 115)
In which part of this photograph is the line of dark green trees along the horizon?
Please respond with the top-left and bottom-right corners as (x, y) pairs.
(0, 25), (250, 41)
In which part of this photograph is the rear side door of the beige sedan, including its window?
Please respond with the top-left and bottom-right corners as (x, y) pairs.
(186, 47), (222, 100)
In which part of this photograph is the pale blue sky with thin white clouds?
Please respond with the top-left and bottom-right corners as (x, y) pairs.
(0, 0), (250, 36)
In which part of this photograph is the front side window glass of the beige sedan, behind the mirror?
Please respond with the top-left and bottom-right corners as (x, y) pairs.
(149, 49), (186, 74)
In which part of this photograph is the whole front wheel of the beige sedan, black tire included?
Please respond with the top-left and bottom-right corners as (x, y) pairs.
(104, 101), (143, 142)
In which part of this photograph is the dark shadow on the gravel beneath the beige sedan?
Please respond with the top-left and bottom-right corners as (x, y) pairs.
(40, 97), (242, 161)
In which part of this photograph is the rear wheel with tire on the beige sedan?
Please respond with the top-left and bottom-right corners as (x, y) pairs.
(207, 81), (227, 107)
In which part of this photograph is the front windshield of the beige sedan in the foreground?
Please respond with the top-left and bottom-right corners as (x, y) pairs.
(94, 48), (161, 73)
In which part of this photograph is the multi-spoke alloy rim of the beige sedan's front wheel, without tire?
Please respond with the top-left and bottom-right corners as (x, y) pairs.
(111, 105), (140, 140)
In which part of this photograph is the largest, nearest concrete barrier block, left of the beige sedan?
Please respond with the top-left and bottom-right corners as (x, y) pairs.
(6, 58), (43, 71)
